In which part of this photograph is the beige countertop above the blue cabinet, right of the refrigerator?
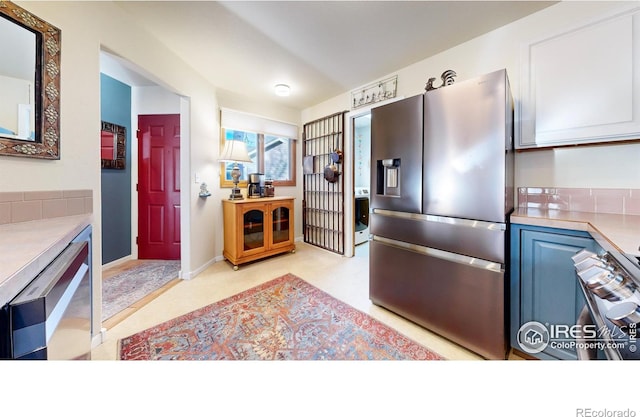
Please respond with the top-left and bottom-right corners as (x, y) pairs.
(511, 208), (640, 256)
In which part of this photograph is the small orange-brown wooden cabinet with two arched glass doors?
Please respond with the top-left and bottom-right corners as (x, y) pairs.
(222, 197), (295, 270)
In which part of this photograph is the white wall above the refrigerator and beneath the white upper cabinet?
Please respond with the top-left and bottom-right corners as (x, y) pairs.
(302, 1), (640, 188)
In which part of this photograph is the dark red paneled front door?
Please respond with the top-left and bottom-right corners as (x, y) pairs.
(138, 114), (180, 259)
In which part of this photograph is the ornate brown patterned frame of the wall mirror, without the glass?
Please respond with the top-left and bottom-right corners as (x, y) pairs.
(0, 0), (62, 159)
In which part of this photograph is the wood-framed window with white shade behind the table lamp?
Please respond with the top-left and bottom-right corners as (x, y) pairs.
(220, 109), (297, 187)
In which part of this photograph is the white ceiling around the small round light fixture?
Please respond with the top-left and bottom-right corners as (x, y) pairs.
(111, 1), (555, 109)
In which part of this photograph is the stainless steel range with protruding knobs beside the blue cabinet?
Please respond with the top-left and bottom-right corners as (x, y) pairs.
(573, 248), (640, 360)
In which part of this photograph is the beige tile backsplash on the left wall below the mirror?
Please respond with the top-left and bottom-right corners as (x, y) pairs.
(0, 190), (93, 224)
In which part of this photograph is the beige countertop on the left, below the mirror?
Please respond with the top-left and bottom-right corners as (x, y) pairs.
(0, 214), (91, 306)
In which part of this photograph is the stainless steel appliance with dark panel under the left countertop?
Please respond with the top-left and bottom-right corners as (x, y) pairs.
(1, 226), (91, 360)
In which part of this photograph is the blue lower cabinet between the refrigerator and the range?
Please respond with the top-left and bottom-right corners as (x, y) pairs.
(510, 224), (599, 359)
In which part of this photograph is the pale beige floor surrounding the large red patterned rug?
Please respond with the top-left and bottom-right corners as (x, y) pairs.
(92, 242), (490, 360)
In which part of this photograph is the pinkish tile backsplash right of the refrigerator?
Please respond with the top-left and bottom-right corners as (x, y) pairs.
(518, 187), (640, 215)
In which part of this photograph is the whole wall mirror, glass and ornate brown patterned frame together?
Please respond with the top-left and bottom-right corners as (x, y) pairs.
(0, 0), (61, 159)
